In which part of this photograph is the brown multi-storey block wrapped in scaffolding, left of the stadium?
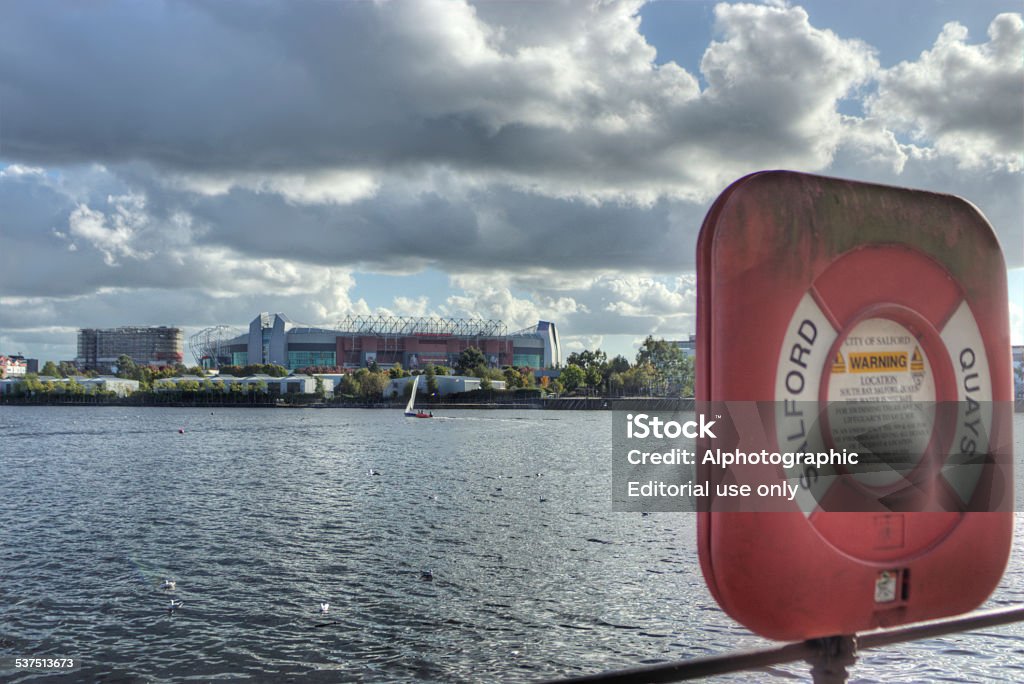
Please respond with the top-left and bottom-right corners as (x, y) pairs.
(75, 326), (184, 373)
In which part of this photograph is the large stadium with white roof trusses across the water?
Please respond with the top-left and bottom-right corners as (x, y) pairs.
(200, 312), (561, 370)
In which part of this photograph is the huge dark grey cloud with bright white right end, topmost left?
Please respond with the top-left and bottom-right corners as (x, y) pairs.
(0, 0), (874, 206)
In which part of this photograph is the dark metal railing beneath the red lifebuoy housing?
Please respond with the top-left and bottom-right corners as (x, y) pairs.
(545, 606), (1024, 684)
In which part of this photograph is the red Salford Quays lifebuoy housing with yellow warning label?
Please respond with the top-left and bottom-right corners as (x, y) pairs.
(696, 171), (1013, 640)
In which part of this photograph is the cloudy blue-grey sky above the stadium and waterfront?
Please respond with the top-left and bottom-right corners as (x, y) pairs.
(0, 0), (1024, 364)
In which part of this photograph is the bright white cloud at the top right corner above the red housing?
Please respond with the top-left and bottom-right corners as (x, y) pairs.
(867, 13), (1024, 171)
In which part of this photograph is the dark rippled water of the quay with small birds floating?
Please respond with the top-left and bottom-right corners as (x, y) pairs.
(0, 407), (1024, 682)
